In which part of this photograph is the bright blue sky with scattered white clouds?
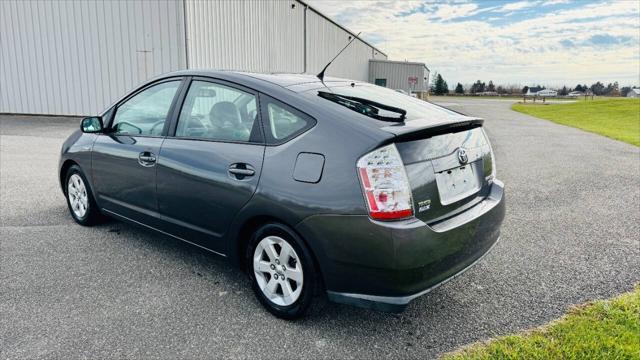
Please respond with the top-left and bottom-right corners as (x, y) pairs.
(307, 0), (640, 88)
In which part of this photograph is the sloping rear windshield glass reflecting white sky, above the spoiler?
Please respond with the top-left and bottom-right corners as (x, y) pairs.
(314, 84), (458, 120)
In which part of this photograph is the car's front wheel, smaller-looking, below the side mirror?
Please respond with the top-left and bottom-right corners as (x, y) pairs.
(64, 165), (102, 226)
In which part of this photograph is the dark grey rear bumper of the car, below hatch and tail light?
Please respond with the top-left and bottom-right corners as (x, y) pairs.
(297, 180), (505, 312)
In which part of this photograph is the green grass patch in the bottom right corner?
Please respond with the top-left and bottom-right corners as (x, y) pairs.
(444, 285), (640, 359)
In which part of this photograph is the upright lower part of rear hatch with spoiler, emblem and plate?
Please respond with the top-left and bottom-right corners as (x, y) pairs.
(382, 118), (493, 224)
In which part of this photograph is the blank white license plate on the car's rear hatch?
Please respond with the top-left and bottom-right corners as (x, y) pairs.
(436, 165), (480, 205)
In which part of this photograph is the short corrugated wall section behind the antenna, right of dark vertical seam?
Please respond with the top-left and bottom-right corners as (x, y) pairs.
(307, 10), (386, 81)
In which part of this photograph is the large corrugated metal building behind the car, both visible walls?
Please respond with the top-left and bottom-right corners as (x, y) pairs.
(0, 0), (387, 115)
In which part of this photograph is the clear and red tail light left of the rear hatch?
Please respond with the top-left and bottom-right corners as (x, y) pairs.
(357, 144), (413, 220)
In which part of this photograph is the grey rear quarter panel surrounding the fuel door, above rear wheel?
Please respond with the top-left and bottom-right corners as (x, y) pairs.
(228, 108), (391, 263)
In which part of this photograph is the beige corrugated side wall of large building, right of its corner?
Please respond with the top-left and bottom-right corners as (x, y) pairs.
(186, 0), (386, 81)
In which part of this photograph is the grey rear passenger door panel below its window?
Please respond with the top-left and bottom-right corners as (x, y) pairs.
(157, 138), (265, 253)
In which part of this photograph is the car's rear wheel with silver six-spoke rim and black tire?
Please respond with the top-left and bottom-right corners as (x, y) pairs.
(247, 223), (319, 320)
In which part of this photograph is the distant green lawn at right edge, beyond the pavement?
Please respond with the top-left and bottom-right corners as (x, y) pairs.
(511, 98), (640, 146)
